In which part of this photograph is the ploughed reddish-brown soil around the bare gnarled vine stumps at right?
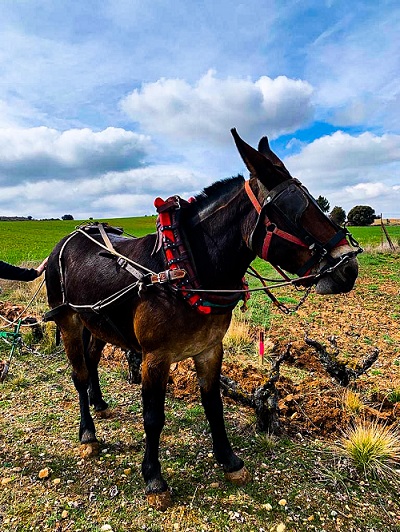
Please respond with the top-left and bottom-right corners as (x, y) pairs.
(0, 264), (400, 438)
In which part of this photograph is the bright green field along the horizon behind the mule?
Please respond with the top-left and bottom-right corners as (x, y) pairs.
(0, 216), (400, 264)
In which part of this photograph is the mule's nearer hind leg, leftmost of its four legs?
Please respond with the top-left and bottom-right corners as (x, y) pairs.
(60, 315), (99, 456)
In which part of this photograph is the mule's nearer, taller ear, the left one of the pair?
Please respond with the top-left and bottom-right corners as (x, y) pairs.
(231, 128), (285, 189)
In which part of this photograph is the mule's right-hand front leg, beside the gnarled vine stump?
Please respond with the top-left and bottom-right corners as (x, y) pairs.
(194, 344), (250, 485)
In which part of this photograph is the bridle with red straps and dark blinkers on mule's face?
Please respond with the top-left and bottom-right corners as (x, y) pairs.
(245, 178), (362, 277)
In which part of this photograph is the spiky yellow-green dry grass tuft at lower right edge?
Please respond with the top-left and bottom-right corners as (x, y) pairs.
(341, 419), (400, 478)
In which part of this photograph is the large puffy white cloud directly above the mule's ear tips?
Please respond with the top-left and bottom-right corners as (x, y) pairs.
(121, 70), (313, 144)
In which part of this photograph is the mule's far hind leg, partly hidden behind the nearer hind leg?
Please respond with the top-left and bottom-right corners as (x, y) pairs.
(82, 328), (109, 417)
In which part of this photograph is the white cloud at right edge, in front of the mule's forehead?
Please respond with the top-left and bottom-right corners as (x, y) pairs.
(285, 131), (400, 217)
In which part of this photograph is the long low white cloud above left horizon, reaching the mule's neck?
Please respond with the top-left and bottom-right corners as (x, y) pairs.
(0, 165), (208, 219)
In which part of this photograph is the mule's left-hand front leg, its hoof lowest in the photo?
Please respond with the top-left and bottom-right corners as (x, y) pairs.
(142, 354), (171, 511)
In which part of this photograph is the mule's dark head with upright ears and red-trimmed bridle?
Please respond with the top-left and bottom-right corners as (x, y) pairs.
(232, 129), (361, 294)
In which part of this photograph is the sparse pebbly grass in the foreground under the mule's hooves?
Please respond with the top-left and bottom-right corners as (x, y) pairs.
(0, 353), (396, 532)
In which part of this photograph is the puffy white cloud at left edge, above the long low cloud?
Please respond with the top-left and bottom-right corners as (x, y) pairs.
(0, 126), (151, 184)
